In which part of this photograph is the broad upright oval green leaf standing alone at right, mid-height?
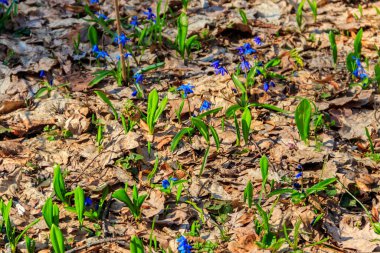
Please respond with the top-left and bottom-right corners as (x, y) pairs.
(294, 99), (311, 143)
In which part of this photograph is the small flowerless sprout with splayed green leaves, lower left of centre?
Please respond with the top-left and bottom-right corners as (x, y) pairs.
(112, 184), (148, 220)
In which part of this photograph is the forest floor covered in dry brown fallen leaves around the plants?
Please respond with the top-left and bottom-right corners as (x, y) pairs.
(0, 0), (380, 253)
